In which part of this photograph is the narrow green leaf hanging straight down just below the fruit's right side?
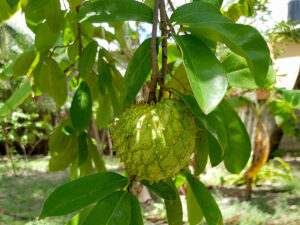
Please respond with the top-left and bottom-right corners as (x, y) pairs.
(165, 178), (183, 225)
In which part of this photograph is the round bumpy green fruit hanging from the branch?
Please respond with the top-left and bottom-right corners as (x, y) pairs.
(112, 99), (197, 183)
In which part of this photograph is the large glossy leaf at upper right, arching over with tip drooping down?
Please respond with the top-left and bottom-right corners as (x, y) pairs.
(171, 2), (270, 87)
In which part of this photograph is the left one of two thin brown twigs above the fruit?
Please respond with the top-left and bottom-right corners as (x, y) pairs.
(148, 0), (158, 103)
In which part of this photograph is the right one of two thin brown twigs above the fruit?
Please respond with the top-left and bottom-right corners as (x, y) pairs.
(158, 0), (168, 101)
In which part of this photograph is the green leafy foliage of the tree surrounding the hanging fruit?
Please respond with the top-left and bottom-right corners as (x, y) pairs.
(0, 0), (290, 225)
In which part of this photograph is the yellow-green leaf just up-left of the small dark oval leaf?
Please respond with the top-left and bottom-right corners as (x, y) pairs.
(36, 58), (68, 109)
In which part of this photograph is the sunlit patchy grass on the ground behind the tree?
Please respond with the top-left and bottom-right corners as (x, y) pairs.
(0, 157), (300, 225)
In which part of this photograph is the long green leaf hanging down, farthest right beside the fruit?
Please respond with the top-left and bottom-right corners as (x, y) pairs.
(219, 100), (251, 174)
